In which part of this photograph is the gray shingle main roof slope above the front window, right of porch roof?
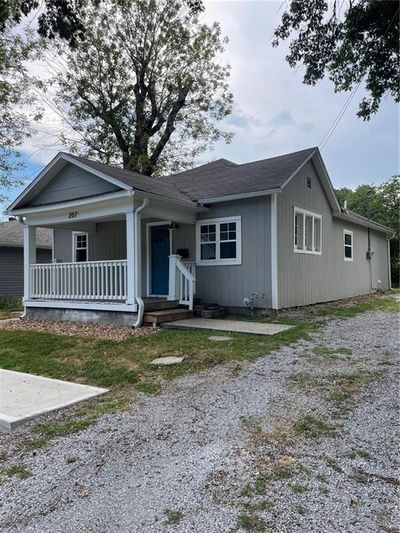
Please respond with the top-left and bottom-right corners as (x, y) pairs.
(162, 148), (318, 200)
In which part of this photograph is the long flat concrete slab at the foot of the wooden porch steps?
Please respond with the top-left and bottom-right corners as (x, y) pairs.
(163, 318), (293, 335)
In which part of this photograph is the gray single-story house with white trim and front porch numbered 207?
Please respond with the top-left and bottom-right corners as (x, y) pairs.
(8, 148), (393, 325)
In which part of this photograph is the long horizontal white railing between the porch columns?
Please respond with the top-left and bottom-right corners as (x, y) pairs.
(30, 259), (127, 300)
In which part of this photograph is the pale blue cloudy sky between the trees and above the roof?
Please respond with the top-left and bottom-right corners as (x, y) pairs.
(2, 0), (399, 216)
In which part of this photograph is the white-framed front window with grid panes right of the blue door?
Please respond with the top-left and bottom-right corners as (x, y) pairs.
(196, 217), (242, 265)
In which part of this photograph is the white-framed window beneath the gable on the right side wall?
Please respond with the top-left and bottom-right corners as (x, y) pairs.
(293, 207), (322, 255)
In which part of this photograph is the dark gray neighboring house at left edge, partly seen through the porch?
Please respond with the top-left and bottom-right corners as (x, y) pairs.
(0, 220), (53, 297)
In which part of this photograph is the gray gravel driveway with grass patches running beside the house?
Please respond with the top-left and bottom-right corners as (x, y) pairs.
(0, 312), (400, 533)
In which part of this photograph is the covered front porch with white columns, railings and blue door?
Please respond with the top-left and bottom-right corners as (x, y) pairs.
(19, 194), (200, 315)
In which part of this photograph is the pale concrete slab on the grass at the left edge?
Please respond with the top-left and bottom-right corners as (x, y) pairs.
(0, 369), (108, 429)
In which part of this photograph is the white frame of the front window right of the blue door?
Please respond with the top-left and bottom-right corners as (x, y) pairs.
(196, 216), (242, 266)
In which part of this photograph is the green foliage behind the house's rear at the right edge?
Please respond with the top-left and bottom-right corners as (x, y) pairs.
(336, 175), (400, 286)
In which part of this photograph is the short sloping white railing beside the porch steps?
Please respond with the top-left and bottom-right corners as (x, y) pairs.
(168, 255), (196, 311)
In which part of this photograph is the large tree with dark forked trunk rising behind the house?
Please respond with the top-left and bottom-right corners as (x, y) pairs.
(56, 0), (232, 175)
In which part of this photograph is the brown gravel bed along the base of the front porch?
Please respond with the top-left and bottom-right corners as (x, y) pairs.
(0, 318), (160, 341)
